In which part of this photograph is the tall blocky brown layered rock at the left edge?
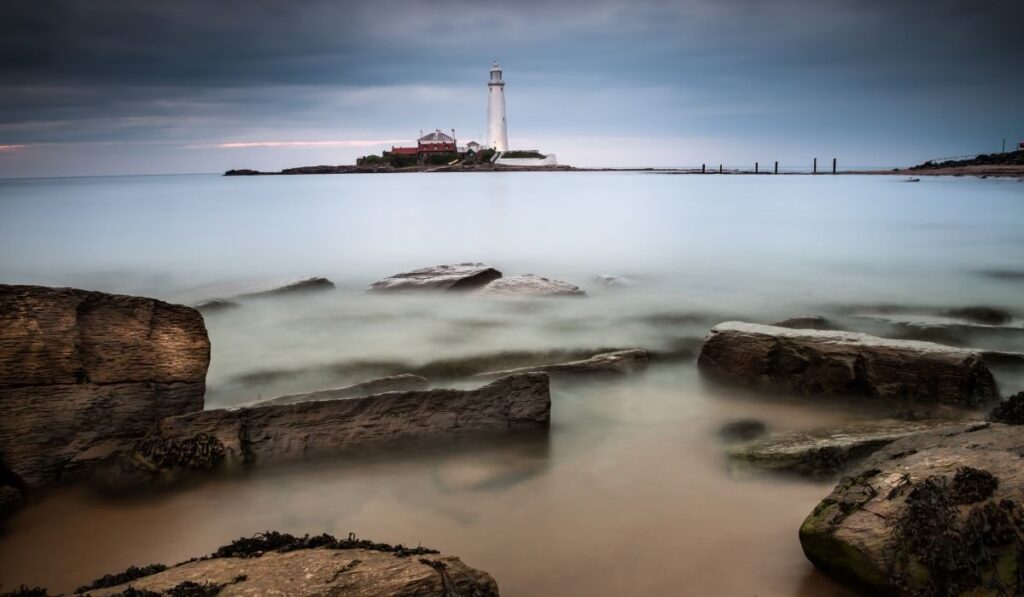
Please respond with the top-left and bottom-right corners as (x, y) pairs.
(0, 286), (210, 488)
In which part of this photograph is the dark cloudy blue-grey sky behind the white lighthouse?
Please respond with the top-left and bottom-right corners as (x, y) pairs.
(0, 0), (1024, 177)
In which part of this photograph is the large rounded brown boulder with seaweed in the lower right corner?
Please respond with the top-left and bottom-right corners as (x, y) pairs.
(800, 424), (1024, 595)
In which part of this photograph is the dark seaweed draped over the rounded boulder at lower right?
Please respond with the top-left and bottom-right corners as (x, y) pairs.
(893, 467), (1024, 597)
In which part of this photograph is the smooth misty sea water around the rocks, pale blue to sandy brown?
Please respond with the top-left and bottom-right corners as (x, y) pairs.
(0, 173), (1024, 595)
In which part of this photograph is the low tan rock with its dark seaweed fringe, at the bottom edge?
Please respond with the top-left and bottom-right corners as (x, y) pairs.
(82, 532), (498, 597)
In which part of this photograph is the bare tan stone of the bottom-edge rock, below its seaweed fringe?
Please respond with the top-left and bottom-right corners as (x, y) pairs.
(86, 548), (498, 597)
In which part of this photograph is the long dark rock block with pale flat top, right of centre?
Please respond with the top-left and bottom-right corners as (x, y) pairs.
(697, 322), (998, 407)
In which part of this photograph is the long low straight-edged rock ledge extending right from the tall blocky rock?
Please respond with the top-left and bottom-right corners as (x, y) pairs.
(140, 373), (551, 472)
